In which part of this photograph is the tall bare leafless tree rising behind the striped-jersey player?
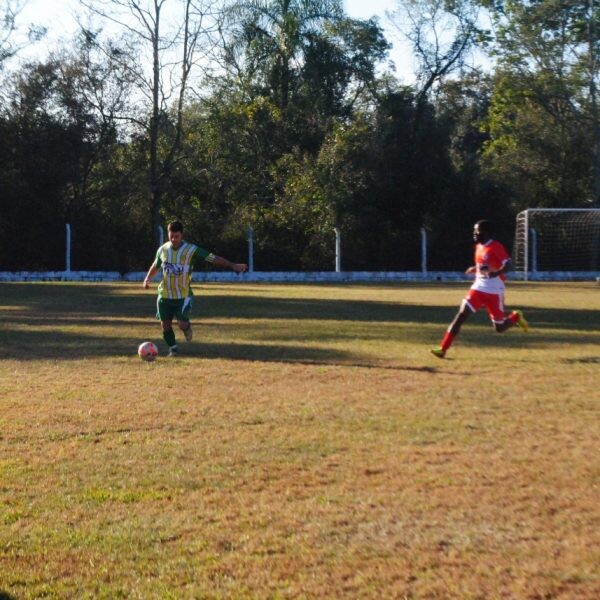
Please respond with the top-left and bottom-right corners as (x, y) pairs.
(80, 0), (223, 244)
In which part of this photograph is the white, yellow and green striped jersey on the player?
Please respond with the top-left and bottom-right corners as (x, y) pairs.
(154, 242), (215, 300)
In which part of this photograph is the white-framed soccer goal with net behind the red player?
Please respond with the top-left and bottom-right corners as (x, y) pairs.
(513, 208), (600, 280)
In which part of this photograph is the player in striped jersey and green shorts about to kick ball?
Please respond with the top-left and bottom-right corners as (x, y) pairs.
(144, 221), (246, 356)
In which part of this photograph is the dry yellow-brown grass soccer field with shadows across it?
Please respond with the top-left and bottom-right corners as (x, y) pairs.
(0, 283), (600, 600)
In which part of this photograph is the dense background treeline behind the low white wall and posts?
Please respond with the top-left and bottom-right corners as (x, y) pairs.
(0, 0), (600, 272)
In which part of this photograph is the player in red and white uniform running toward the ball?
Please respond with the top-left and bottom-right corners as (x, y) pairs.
(431, 221), (529, 358)
